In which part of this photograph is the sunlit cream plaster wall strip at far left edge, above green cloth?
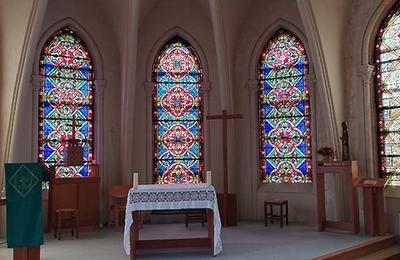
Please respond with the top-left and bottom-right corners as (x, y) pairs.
(0, 0), (46, 237)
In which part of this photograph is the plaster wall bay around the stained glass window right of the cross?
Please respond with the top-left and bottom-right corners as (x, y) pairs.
(233, 0), (352, 224)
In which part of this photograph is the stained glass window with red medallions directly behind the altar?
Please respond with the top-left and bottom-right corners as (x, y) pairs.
(153, 37), (203, 184)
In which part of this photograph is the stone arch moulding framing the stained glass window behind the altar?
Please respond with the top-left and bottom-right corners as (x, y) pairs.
(143, 27), (211, 183)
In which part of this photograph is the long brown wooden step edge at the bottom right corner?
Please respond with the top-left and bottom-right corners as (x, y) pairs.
(313, 234), (398, 260)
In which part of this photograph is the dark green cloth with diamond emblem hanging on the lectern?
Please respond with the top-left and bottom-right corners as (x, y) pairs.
(5, 163), (43, 248)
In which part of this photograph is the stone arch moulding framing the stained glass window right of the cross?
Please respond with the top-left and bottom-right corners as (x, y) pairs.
(247, 19), (317, 194)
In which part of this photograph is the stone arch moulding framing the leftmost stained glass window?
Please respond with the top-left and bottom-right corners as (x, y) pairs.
(31, 18), (105, 177)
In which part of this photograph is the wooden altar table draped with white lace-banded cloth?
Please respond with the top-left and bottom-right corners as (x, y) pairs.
(124, 184), (222, 259)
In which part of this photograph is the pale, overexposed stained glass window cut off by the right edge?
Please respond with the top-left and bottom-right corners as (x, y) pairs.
(375, 2), (400, 186)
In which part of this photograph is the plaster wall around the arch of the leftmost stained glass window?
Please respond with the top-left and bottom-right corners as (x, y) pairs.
(2, 0), (121, 224)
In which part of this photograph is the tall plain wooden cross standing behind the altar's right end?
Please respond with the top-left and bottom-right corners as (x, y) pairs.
(206, 109), (243, 226)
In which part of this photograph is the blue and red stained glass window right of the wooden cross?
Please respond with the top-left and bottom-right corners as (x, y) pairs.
(258, 29), (311, 183)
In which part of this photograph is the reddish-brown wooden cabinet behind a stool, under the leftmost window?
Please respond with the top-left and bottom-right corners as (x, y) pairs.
(47, 165), (100, 232)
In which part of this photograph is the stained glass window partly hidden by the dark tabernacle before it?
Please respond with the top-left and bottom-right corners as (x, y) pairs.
(39, 28), (94, 177)
